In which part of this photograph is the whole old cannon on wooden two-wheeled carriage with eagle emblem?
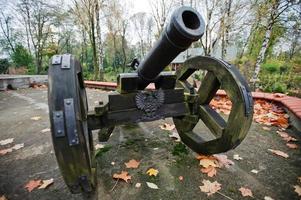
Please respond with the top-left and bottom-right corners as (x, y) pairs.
(48, 7), (253, 193)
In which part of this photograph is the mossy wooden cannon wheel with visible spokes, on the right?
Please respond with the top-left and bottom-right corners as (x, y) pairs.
(173, 56), (253, 154)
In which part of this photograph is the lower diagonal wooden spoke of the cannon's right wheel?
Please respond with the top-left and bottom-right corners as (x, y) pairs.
(199, 105), (227, 137)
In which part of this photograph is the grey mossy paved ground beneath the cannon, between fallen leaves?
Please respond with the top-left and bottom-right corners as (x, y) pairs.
(0, 89), (301, 200)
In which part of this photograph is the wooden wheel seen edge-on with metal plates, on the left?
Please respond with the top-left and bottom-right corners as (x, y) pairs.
(48, 54), (96, 193)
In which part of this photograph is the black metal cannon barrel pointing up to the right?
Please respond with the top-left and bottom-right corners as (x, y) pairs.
(137, 6), (205, 89)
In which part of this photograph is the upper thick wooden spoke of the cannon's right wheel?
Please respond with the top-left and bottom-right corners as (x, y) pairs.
(198, 71), (220, 105)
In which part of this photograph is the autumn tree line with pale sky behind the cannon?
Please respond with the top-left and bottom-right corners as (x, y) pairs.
(0, 0), (301, 94)
